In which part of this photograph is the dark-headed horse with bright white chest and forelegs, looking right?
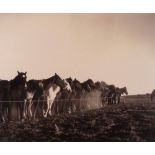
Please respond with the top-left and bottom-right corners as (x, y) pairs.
(43, 73), (70, 118)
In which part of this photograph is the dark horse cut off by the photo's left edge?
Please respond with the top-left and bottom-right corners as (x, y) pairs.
(0, 80), (10, 122)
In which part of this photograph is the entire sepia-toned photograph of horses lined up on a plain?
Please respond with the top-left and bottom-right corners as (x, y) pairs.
(0, 13), (155, 142)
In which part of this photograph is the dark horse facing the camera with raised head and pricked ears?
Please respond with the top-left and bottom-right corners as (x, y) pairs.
(8, 71), (27, 120)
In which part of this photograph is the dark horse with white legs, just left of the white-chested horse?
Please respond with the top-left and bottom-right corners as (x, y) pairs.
(25, 80), (43, 118)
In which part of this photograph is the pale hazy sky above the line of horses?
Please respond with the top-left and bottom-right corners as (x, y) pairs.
(0, 14), (155, 94)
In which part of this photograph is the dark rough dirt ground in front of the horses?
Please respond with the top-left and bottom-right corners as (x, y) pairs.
(0, 95), (155, 142)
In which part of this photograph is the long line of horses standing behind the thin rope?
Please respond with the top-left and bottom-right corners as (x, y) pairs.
(0, 72), (128, 122)
